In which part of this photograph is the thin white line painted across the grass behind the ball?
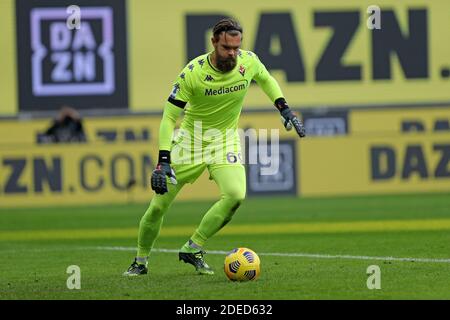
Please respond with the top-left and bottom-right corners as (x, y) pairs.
(92, 247), (450, 263)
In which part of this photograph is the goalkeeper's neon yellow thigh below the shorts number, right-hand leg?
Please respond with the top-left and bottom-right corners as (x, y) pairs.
(208, 164), (246, 200)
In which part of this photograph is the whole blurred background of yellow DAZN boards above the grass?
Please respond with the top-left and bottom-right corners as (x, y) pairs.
(0, 0), (450, 208)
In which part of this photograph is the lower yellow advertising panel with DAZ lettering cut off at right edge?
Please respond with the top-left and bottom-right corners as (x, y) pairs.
(298, 133), (450, 196)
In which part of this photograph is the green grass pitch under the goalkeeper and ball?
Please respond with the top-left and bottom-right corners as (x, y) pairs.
(0, 194), (450, 300)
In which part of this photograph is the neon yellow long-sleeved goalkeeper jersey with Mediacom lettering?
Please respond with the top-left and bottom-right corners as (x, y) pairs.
(159, 50), (283, 163)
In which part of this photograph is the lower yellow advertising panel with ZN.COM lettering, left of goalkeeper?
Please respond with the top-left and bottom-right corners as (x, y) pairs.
(0, 143), (219, 207)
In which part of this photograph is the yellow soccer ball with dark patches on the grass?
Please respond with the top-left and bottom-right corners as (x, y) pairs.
(224, 248), (260, 281)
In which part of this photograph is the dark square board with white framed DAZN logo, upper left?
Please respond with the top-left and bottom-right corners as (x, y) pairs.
(16, 0), (128, 111)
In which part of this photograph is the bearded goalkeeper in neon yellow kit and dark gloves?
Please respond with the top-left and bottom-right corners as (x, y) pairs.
(124, 18), (305, 276)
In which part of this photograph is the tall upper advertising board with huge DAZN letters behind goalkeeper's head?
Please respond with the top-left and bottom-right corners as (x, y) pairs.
(0, 0), (450, 116)
